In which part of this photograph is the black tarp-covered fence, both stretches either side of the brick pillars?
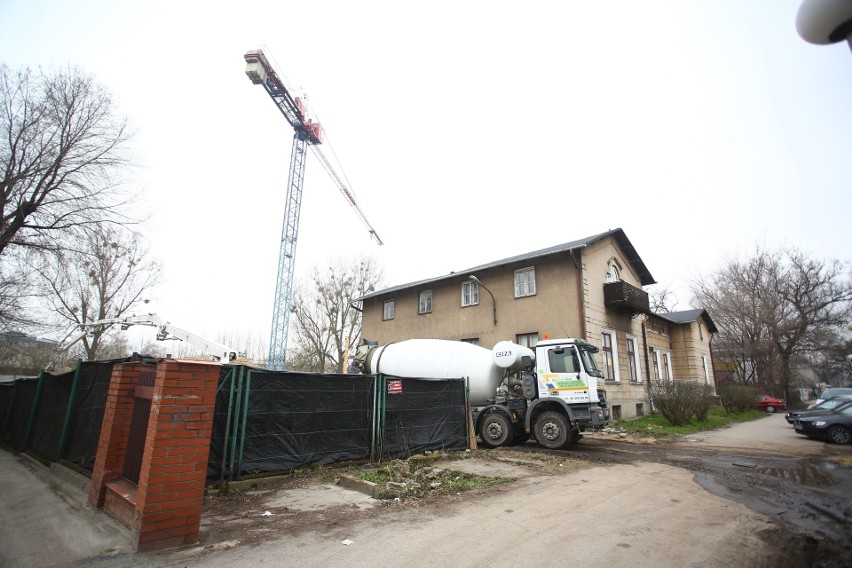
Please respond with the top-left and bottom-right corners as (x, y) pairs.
(0, 359), (468, 480)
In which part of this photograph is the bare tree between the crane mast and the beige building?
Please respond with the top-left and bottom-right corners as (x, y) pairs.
(287, 257), (382, 373)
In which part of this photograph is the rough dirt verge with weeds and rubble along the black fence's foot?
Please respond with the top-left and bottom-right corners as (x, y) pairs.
(201, 449), (593, 544)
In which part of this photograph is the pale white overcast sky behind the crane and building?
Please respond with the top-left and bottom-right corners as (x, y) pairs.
(0, 0), (852, 350)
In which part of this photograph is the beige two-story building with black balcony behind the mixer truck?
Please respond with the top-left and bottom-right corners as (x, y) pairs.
(359, 229), (717, 419)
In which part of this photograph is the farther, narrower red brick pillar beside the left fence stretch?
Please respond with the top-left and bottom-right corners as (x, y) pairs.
(89, 363), (145, 508)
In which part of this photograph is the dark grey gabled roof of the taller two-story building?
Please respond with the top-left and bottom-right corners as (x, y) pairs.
(356, 229), (657, 301)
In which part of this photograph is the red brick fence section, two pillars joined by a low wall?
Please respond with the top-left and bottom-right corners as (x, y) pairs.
(90, 360), (221, 551)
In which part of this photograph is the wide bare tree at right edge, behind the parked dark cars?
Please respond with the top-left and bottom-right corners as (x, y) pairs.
(693, 247), (852, 396)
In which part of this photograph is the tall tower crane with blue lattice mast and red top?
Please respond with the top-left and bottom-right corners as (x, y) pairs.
(244, 49), (384, 371)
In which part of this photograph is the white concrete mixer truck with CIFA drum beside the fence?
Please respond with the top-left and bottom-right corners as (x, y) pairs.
(354, 339), (609, 449)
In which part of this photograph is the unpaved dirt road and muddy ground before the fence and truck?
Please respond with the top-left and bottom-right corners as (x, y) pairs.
(78, 416), (852, 568)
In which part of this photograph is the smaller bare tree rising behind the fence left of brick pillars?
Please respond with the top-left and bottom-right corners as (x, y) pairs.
(38, 226), (160, 360)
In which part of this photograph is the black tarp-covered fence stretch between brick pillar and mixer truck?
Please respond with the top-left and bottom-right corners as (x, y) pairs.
(207, 367), (468, 480)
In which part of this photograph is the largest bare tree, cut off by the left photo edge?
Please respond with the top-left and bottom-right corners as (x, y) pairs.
(0, 65), (131, 256)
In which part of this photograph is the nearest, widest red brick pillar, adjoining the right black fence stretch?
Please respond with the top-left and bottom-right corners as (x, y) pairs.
(131, 360), (222, 551)
